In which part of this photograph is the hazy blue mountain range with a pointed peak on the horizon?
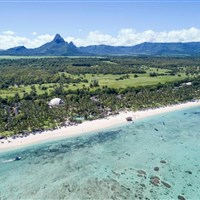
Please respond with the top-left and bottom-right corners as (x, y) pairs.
(0, 34), (200, 56)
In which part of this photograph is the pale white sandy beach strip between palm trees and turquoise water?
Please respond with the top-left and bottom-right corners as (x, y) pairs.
(0, 100), (200, 152)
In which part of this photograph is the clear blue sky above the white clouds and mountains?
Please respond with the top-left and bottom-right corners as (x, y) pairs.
(0, 0), (200, 48)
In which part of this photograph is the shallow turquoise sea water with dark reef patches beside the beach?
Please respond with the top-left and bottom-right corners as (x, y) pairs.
(0, 107), (200, 200)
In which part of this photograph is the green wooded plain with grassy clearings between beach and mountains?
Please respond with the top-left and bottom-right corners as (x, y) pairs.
(0, 57), (200, 137)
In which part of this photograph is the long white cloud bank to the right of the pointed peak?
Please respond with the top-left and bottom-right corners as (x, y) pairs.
(69, 28), (200, 46)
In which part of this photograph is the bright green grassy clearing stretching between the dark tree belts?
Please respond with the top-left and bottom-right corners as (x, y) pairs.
(0, 68), (187, 98)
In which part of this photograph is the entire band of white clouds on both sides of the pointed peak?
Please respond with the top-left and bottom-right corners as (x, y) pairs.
(0, 27), (200, 49)
